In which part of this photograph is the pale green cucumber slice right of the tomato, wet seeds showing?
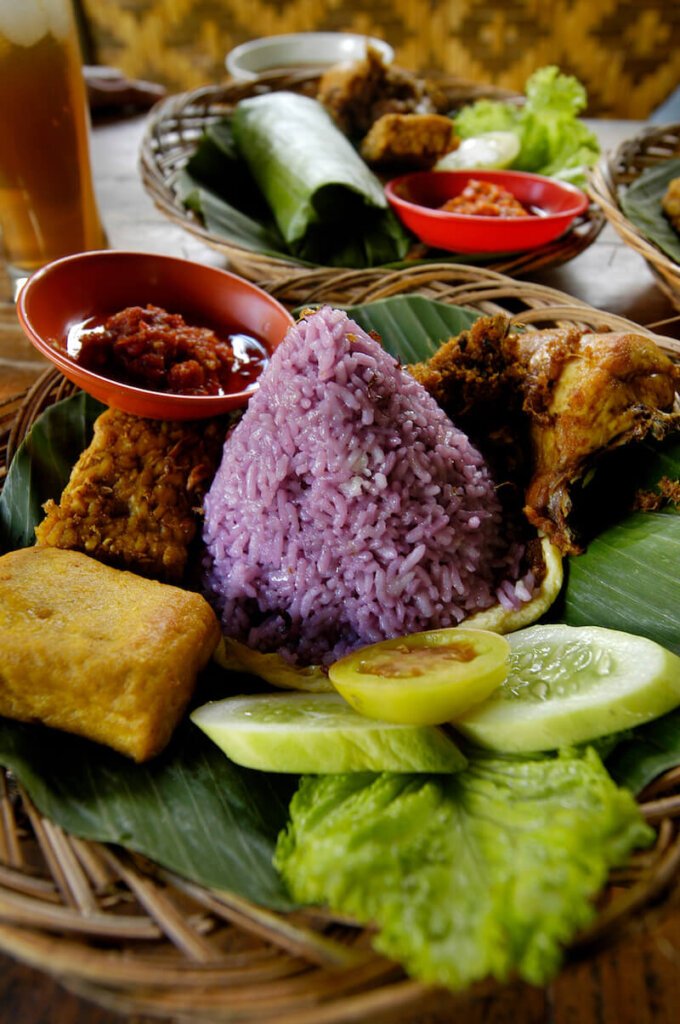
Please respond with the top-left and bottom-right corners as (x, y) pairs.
(454, 625), (680, 753)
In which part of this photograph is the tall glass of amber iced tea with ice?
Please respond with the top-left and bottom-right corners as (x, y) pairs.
(0, 0), (105, 288)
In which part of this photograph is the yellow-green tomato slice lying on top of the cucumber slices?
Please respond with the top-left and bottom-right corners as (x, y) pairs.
(329, 627), (509, 725)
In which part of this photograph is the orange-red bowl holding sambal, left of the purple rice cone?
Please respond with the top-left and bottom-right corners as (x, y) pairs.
(17, 250), (294, 420)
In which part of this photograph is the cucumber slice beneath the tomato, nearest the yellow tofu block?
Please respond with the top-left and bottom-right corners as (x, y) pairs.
(192, 693), (466, 775)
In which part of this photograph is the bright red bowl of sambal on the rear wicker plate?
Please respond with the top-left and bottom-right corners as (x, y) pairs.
(385, 170), (588, 253)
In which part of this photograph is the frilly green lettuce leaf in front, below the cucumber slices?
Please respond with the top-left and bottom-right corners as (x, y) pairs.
(274, 749), (653, 989)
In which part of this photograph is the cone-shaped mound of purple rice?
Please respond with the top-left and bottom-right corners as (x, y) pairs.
(204, 307), (530, 665)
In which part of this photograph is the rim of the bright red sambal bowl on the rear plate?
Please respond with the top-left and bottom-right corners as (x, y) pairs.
(385, 167), (590, 224)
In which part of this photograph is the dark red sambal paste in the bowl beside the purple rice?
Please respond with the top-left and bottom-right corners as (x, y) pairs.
(62, 305), (267, 394)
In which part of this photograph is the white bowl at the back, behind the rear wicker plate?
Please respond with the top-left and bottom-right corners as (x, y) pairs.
(224, 32), (394, 82)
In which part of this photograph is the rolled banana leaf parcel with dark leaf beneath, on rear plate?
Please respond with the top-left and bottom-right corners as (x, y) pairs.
(180, 92), (412, 268)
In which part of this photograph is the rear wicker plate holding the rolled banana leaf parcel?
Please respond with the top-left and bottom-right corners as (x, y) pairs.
(140, 73), (604, 301)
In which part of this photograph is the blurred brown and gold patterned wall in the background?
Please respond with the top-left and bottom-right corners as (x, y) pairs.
(76, 0), (680, 118)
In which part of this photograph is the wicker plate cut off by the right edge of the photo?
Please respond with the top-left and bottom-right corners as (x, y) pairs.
(590, 124), (680, 309)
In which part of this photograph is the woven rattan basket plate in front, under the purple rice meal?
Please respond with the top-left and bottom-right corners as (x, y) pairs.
(0, 265), (680, 1024)
